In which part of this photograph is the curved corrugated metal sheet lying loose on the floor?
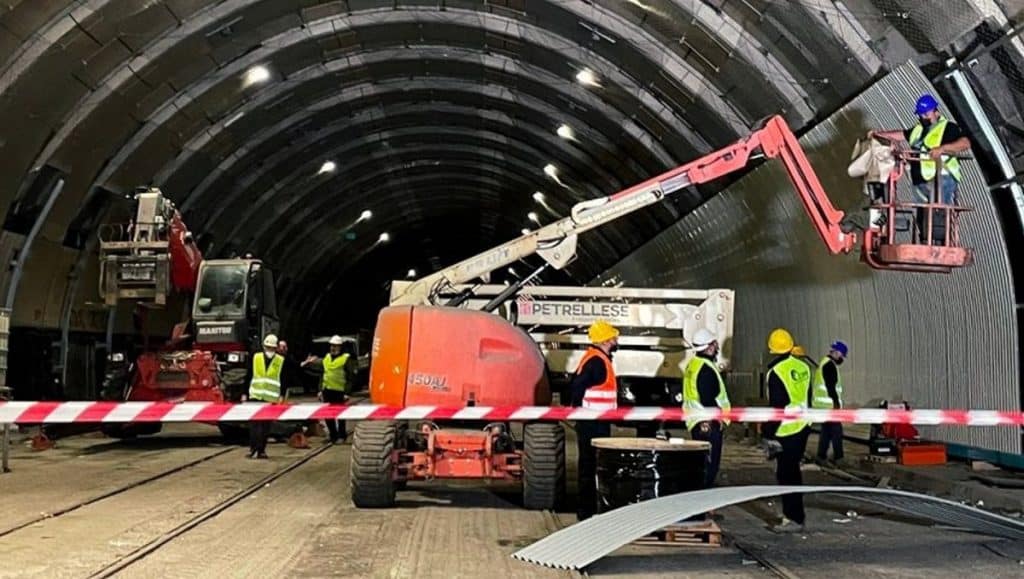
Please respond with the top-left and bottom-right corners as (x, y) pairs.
(512, 485), (1024, 570)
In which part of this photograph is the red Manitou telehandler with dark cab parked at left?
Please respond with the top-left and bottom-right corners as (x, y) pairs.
(99, 189), (278, 436)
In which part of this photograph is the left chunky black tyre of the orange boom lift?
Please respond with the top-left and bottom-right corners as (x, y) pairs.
(349, 420), (398, 508)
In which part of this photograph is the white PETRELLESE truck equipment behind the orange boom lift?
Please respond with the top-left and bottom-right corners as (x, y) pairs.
(391, 281), (735, 406)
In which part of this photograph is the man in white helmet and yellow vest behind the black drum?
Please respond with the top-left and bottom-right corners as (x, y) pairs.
(683, 328), (731, 488)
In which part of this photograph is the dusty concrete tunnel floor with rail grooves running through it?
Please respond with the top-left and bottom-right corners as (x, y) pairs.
(0, 425), (1024, 578)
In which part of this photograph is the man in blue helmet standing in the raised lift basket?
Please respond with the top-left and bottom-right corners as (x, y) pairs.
(867, 94), (971, 245)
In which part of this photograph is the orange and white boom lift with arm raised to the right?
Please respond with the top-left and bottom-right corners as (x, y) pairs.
(351, 112), (971, 508)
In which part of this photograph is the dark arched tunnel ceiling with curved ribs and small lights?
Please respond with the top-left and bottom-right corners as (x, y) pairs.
(0, 0), (1007, 334)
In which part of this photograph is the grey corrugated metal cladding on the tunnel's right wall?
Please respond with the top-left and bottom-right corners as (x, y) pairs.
(600, 64), (1021, 453)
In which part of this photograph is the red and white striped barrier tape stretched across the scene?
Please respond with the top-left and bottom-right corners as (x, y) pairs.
(0, 402), (1024, 426)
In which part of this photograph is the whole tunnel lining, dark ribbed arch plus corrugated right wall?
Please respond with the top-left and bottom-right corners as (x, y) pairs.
(0, 0), (1024, 452)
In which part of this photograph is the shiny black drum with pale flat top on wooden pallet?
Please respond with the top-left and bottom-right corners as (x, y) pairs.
(592, 438), (711, 513)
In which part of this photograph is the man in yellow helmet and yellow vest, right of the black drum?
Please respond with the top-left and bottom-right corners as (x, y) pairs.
(764, 328), (811, 533)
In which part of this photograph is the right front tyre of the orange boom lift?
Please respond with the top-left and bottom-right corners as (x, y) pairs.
(522, 423), (565, 510)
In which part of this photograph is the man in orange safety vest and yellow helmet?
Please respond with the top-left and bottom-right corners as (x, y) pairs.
(569, 320), (618, 521)
